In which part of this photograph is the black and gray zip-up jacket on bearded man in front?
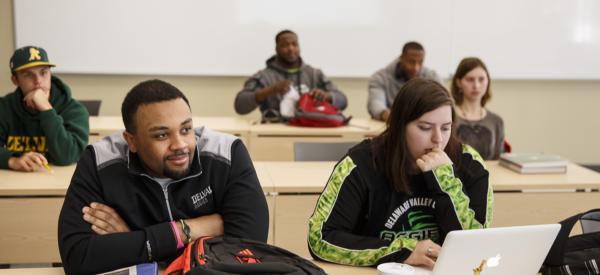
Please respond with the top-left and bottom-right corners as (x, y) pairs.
(58, 127), (269, 274)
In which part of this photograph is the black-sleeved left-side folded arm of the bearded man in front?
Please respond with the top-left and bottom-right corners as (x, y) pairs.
(58, 149), (177, 274)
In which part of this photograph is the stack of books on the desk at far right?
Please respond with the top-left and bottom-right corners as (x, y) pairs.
(500, 153), (569, 174)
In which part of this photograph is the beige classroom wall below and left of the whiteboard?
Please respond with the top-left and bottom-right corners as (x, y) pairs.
(0, 0), (600, 164)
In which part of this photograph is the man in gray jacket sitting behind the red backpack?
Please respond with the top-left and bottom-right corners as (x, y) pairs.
(234, 30), (347, 121)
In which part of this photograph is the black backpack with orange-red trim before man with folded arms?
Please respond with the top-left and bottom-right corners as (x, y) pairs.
(164, 237), (327, 275)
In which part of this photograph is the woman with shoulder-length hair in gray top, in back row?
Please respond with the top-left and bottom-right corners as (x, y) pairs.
(450, 57), (504, 160)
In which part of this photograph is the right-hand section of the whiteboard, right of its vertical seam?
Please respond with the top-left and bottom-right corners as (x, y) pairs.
(452, 0), (600, 79)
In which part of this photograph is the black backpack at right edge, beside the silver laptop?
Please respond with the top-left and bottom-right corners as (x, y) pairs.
(540, 209), (600, 275)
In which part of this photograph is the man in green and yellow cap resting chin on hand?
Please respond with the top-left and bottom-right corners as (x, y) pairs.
(0, 46), (89, 172)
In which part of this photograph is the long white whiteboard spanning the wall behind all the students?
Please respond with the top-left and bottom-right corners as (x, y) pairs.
(14, 0), (600, 79)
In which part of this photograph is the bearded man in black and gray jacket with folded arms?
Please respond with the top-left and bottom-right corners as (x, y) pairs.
(58, 80), (269, 274)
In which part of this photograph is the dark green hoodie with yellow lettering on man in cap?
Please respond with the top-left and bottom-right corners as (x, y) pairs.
(0, 76), (89, 169)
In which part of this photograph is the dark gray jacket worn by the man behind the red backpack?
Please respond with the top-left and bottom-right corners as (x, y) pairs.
(234, 56), (348, 119)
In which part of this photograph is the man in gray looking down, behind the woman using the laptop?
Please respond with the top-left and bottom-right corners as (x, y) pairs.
(367, 41), (440, 121)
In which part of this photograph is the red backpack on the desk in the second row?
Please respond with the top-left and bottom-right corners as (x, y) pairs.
(288, 94), (352, 127)
